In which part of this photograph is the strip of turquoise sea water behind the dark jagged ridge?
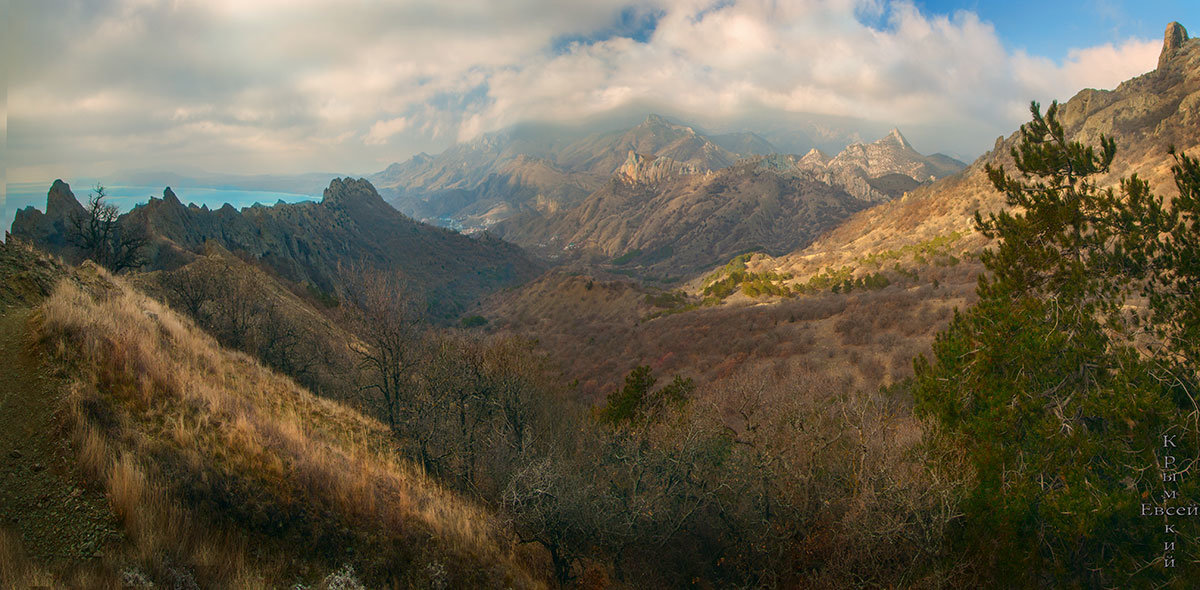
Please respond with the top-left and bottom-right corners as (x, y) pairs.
(0, 181), (320, 236)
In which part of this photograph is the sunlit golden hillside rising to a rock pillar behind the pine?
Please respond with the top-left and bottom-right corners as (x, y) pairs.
(758, 24), (1200, 285)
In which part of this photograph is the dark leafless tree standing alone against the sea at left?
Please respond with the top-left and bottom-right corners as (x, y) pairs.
(67, 185), (146, 272)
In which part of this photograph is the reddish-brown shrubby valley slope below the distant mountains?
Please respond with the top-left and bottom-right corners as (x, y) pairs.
(480, 265), (974, 403)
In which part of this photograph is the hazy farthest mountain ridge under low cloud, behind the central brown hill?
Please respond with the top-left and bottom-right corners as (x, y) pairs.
(371, 114), (775, 230)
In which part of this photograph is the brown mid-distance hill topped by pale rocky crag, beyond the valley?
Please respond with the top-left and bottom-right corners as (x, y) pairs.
(498, 153), (866, 277)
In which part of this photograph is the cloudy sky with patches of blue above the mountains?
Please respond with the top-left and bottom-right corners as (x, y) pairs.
(4, 0), (1200, 182)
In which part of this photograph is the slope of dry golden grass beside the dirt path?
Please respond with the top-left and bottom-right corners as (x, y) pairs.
(38, 265), (540, 588)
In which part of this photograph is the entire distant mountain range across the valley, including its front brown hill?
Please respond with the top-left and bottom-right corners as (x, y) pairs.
(371, 114), (965, 276)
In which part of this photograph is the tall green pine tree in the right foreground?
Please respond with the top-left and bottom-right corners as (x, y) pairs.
(914, 103), (1200, 588)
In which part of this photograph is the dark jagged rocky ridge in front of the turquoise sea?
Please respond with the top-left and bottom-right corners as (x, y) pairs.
(12, 179), (539, 319)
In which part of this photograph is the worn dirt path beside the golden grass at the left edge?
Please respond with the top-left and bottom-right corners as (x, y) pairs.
(0, 308), (121, 564)
